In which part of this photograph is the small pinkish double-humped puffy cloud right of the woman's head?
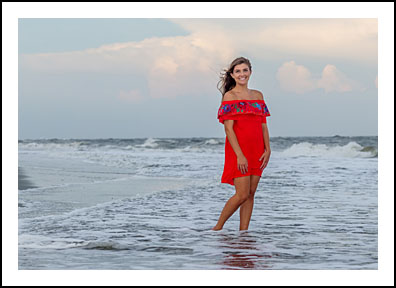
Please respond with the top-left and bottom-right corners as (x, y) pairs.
(276, 61), (360, 94)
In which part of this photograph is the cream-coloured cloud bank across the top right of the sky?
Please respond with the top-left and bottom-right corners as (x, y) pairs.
(170, 18), (378, 65)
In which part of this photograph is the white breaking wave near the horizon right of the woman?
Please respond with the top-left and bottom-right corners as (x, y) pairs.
(282, 141), (378, 158)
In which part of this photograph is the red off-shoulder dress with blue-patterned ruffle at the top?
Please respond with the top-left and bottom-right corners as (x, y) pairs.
(217, 100), (270, 185)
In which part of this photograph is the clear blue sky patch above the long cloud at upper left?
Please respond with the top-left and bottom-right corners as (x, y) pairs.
(18, 18), (188, 54)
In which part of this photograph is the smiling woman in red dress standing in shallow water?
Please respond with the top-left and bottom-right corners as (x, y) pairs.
(212, 57), (271, 230)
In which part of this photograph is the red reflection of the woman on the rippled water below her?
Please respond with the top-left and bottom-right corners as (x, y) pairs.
(221, 231), (272, 269)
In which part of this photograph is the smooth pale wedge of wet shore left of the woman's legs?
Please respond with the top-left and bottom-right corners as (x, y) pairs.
(18, 161), (189, 217)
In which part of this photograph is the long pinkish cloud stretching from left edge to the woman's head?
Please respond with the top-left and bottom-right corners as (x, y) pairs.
(20, 33), (229, 99)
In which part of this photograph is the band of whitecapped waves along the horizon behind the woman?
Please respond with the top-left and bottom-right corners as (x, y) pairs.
(18, 136), (378, 161)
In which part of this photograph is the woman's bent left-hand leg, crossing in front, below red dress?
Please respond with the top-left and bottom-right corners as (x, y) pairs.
(212, 175), (250, 230)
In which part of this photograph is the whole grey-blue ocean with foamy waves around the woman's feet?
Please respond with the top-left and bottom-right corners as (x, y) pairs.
(18, 136), (378, 270)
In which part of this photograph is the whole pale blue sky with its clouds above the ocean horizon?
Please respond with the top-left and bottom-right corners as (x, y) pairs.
(18, 17), (378, 139)
